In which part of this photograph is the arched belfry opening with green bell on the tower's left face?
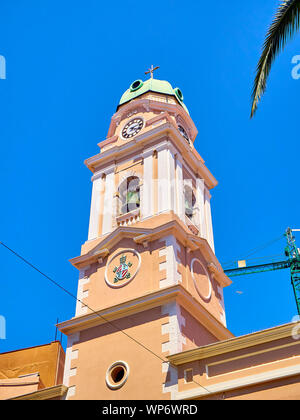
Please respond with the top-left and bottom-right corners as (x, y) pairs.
(119, 176), (140, 214)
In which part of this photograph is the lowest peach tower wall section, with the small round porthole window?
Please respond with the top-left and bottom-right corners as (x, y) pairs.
(67, 302), (216, 400)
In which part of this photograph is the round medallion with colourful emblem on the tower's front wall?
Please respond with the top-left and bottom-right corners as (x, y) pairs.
(104, 249), (141, 288)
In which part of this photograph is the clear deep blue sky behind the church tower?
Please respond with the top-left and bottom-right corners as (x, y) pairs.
(0, 0), (300, 351)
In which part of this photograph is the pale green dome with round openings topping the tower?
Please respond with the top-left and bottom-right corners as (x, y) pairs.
(118, 79), (189, 113)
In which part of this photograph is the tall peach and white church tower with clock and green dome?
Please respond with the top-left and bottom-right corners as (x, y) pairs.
(59, 67), (233, 400)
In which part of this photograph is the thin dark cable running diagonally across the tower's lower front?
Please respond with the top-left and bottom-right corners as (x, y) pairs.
(0, 241), (211, 394)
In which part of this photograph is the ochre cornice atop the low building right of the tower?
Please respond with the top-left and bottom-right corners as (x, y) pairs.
(167, 323), (295, 366)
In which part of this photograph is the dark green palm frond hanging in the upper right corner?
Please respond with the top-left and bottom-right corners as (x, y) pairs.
(251, 0), (300, 118)
